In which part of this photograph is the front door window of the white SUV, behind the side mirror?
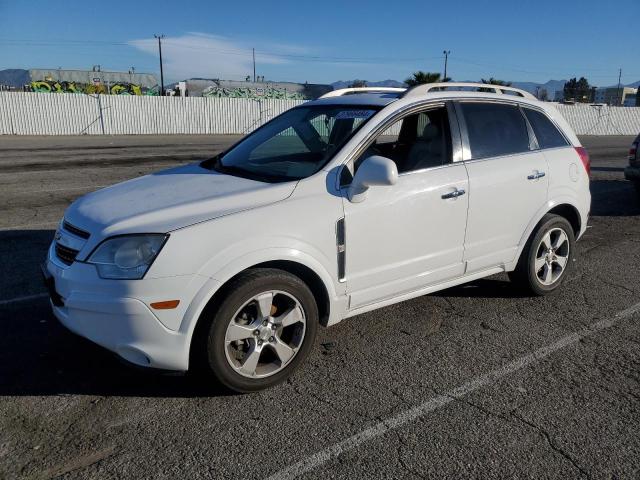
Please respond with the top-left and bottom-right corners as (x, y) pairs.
(355, 107), (451, 173)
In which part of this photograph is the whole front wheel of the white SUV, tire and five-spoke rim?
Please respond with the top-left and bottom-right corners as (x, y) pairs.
(200, 268), (318, 393)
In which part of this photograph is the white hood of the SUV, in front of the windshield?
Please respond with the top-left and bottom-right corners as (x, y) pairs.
(65, 164), (296, 236)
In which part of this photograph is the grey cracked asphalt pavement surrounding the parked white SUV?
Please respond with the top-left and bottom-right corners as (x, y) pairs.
(0, 136), (640, 479)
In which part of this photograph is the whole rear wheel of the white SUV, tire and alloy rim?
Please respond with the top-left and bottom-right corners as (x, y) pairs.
(509, 214), (575, 295)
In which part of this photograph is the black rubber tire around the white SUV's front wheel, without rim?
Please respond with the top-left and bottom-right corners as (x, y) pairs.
(195, 268), (319, 393)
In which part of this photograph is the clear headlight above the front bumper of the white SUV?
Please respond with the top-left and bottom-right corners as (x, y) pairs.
(87, 234), (167, 280)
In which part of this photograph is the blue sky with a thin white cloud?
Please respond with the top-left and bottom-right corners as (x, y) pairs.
(0, 0), (640, 86)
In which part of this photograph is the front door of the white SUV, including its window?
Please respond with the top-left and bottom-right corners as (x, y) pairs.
(344, 106), (469, 309)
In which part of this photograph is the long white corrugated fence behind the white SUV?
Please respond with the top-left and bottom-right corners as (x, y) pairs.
(0, 92), (640, 135)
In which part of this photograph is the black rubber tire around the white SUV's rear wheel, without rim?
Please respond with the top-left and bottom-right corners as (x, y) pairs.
(509, 214), (575, 295)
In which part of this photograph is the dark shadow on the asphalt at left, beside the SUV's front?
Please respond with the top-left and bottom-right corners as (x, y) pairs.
(0, 230), (230, 397)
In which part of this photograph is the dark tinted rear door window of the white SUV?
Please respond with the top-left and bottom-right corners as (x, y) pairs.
(460, 102), (529, 158)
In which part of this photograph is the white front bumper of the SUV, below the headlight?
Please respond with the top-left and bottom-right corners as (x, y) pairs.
(42, 242), (206, 371)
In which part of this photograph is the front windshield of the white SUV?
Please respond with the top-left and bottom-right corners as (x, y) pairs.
(204, 105), (377, 182)
